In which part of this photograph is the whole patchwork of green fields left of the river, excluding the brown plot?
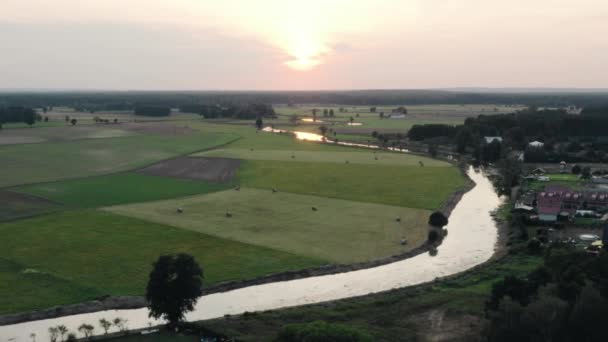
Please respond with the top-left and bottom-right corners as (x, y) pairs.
(0, 119), (464, 314)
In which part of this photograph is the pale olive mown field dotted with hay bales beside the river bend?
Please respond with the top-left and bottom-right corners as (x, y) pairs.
(106, 188), (430, 263)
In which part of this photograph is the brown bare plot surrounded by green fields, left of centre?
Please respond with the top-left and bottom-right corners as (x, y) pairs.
(138, 157), (241, 183)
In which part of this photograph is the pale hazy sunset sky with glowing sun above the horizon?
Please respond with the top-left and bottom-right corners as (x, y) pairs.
(0, 0), (608, 90)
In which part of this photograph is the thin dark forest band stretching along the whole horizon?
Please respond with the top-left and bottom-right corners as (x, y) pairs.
(0, 90), (608, 111)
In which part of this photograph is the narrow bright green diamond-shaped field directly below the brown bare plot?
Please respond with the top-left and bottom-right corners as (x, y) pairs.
(13, 173), (230, 208)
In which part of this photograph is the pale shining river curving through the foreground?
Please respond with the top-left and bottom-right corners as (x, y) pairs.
(0, 151), (501, 341)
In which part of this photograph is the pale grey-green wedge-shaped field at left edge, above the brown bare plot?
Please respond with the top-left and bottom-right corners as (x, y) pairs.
(0, 134), (238, 187)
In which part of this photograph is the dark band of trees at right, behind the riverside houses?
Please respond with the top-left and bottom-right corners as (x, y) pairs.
(408, 109), (608, 162)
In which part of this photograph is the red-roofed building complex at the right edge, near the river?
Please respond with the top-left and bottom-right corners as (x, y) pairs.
(536, 186), (608, 222)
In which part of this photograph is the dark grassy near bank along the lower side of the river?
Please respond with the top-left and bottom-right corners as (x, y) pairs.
(198, 204), (542, 342)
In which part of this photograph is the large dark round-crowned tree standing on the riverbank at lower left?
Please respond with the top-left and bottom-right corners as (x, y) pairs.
(146, 254), (203, 324)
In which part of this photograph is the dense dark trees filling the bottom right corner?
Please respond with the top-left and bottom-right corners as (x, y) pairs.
(486, 246), (608, 342)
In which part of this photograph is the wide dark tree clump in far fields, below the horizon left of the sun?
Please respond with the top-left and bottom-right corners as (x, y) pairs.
(180, 103), (276, 120)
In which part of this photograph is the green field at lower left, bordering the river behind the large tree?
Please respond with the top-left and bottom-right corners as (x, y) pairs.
(0, 210), (325, 314)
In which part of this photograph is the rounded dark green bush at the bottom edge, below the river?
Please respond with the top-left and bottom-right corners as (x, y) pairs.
(276, 321), (372, 342)
